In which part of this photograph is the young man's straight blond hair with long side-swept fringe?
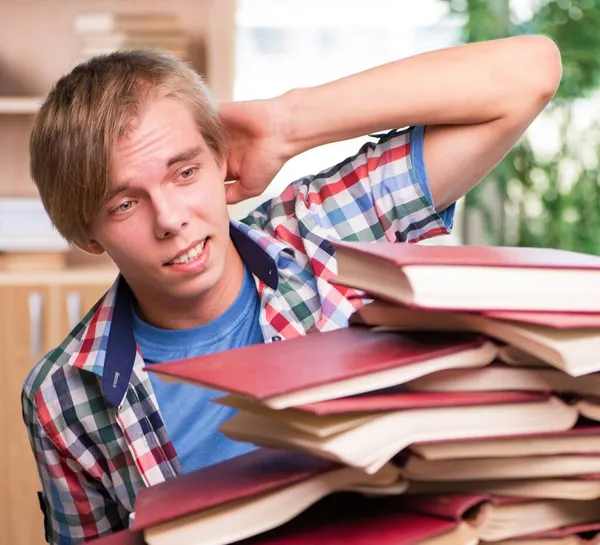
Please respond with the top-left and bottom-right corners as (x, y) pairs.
(29, 51), (226, 245)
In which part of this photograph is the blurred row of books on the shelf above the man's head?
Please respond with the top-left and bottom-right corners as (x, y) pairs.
(73, 12), (189, 62)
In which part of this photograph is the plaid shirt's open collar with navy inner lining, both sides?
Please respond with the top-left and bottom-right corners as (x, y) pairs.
(69, 220), (286, 407)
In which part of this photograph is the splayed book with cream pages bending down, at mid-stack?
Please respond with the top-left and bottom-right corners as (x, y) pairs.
(219, 392), (578, 473)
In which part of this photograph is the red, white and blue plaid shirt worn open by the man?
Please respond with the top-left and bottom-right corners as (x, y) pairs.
(22, 126), (448, 544)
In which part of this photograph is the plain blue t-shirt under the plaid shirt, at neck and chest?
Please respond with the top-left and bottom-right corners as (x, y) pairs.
(133, 269), (264, 473)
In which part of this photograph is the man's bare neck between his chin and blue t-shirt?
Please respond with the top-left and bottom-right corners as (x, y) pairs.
(134, 241), (244, 329)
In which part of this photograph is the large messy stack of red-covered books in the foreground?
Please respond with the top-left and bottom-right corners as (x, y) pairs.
(92, 243), (600, 545)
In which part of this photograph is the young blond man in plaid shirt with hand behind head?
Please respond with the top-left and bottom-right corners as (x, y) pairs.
(23, 36), (561, 544)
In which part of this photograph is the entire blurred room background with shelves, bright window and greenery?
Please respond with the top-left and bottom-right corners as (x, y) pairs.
(0, 0), (600, 545)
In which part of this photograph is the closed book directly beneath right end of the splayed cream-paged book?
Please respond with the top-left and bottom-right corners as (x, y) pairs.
(410, 425), (600, 460)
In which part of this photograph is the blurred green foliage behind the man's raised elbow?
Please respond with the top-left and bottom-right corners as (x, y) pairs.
(444, 0), (600, 253)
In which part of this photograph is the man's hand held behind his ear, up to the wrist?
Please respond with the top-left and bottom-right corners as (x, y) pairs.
(220, 99), (290, 204)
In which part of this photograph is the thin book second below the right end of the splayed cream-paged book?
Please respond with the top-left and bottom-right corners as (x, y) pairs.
(401, 453), (600, 481)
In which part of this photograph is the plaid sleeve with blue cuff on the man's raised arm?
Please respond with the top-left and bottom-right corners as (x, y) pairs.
(244, 127), (454, 246)
